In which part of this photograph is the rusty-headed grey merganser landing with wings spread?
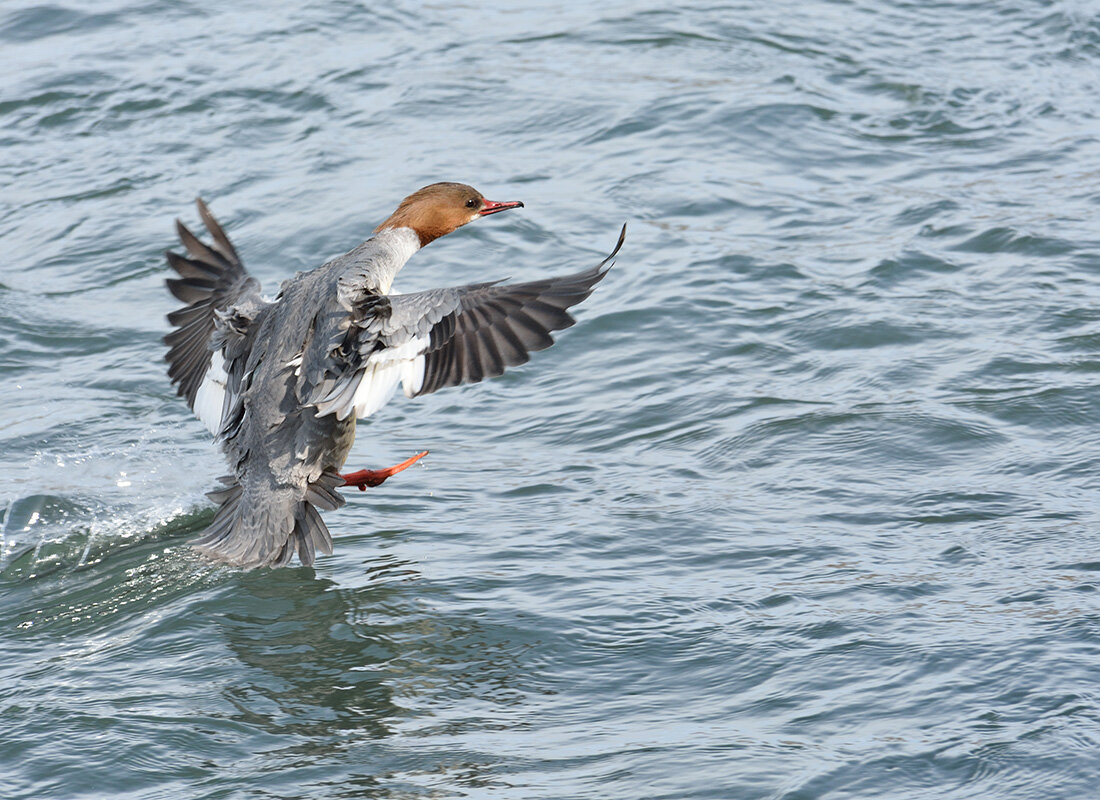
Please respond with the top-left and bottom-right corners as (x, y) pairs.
(164, 183), (626, 569)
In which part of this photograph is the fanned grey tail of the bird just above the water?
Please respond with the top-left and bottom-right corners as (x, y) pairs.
(191, 472), (344, 569)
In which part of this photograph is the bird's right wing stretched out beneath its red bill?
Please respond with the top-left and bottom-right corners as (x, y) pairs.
(315, 226), (626, 418)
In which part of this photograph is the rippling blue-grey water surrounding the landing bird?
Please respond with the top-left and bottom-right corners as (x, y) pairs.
(0, 0), (1100, 800)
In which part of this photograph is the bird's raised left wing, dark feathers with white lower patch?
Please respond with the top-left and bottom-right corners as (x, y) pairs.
(164, 199), (265, 434)
